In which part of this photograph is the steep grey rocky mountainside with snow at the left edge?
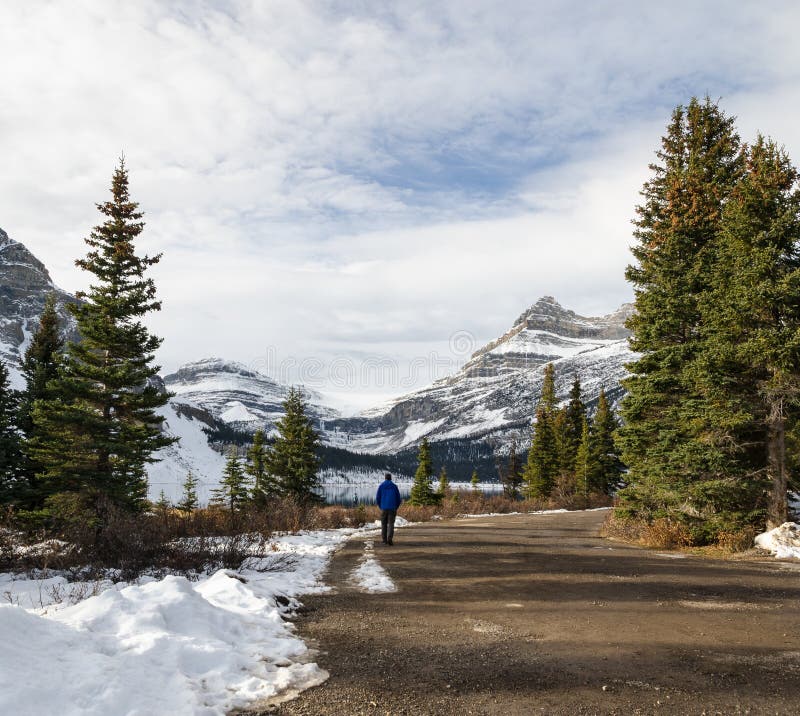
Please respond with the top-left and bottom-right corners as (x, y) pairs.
(0, 229), (75, 388)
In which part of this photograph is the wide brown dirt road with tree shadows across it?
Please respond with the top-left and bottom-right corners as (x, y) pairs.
(245, 512), (800, 716)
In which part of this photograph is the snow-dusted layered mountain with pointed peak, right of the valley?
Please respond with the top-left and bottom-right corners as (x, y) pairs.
(331, 296), (634, 453)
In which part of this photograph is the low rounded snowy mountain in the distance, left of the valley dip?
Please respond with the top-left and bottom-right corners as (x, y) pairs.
(164, 358), (338, 432)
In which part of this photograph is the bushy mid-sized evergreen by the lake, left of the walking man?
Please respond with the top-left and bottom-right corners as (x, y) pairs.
(266, 388), (321, 503)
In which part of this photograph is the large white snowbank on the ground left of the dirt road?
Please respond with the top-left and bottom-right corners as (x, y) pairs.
(0, 526), (374, 716)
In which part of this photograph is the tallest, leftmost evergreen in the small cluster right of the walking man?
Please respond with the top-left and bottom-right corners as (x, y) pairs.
(522, 363), (559, 499)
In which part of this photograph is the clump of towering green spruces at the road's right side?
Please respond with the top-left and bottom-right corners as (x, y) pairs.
(618, 98), (800, 542)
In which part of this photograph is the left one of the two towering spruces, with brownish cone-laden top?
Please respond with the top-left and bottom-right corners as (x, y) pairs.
(620, 99), (743, 519)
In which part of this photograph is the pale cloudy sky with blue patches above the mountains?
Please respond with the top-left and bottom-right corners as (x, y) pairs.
(0, 0), (800, 412)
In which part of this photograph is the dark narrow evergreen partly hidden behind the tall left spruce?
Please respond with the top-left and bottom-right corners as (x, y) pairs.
(19, 293), (64, 508)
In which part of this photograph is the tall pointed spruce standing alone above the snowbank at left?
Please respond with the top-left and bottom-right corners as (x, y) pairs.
(29, 160), (173, 526)
